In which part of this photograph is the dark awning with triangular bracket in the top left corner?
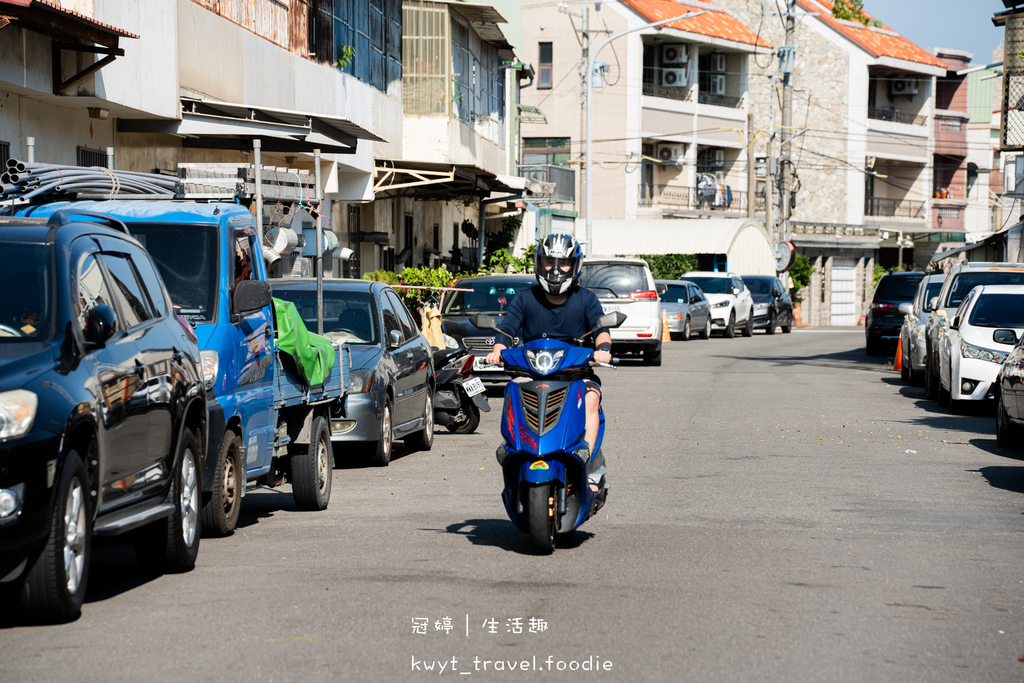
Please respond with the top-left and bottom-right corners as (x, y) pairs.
(0, 0), (138, 95)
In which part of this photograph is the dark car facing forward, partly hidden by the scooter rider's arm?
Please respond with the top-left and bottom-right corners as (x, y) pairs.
(441, 275), (537, 382)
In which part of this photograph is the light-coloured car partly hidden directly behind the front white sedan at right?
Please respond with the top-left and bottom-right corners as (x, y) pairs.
(925, 261), (1024, 399)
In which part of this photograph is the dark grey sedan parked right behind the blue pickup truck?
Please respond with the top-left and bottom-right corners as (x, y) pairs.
(270, 279), (434, 467)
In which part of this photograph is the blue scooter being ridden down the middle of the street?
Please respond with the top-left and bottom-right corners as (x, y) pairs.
(470, 311), (626, 554)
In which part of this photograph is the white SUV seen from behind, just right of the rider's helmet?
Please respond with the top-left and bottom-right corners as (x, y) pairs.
(580, 258), (662, 366)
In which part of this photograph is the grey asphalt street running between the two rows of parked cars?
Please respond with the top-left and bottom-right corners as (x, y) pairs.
(0, 329), (1024, 682)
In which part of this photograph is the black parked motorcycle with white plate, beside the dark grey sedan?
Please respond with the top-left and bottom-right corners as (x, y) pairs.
(433, 341), (490, 434)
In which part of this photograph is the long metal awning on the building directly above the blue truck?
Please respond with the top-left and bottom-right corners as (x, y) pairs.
(118, 97), (387, 155)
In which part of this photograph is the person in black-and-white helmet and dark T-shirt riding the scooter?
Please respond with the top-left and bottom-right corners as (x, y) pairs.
(486, 233), (611, 492)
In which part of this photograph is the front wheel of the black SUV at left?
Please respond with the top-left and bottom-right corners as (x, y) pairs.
(22, 451), (92, 624)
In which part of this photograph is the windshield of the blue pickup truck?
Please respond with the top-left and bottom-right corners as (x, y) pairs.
(131, 224), (218, 323)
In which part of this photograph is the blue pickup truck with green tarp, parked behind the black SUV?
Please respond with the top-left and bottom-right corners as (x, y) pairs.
(19, 200), (349, 536)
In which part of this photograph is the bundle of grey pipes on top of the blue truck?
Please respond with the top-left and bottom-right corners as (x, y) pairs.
(0, 159), (178, 200)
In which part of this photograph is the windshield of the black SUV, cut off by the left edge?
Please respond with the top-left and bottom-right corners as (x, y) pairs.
(0, 244), (53, 342)
